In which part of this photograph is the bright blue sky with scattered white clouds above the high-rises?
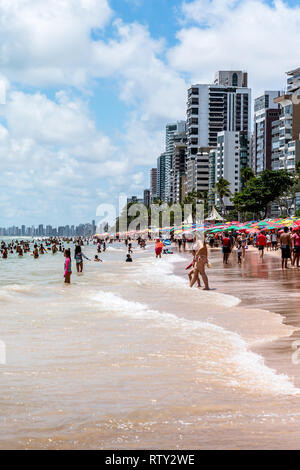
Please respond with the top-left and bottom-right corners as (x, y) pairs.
(0, 0), (300, 227)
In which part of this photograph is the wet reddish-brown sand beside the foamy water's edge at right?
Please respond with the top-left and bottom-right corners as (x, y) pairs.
(176, 247), (300, 388)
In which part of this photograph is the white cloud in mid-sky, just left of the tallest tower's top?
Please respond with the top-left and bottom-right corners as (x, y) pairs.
(94, 20), (186, 122)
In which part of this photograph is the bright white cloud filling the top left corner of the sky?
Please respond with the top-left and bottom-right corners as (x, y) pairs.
(0, 0), (112, 85)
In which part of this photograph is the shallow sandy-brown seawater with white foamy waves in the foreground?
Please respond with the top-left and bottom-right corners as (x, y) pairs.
(0, 243), (300, 449)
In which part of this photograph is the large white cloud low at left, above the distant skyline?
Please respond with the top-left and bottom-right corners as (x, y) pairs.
(0, 91), (123, 223)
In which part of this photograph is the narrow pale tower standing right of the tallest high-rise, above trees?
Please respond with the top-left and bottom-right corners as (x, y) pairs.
(252, 91), (281, 174)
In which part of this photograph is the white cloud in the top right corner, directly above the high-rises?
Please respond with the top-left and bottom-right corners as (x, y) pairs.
(168, 0), (300, 96)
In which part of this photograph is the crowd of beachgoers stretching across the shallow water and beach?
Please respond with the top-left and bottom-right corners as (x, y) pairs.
(0, 227), (300, 290)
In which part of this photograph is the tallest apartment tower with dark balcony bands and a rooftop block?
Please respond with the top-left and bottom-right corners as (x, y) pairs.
(187, 71), (251, 158)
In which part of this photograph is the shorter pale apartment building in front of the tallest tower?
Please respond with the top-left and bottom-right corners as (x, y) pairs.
(209, 131), (249, 209)
